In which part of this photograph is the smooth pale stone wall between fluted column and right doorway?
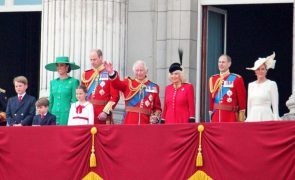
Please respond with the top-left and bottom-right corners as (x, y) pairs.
(127, 0), (197, 100)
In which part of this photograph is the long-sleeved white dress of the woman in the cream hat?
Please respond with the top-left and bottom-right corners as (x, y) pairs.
(246, 79), (280, 122)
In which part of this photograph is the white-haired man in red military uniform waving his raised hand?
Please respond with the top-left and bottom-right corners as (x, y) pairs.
(105, 61), (162, 125)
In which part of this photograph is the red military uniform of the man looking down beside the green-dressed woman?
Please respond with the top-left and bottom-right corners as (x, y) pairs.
(81, 65), (120, 124)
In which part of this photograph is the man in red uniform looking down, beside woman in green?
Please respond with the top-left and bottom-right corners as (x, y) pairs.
(81, 49), (120, 124)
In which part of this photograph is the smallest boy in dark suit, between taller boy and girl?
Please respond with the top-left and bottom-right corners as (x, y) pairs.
(33, 97), (56, 126)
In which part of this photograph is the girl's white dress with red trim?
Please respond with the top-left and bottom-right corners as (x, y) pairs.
(68, 101), (94, 125)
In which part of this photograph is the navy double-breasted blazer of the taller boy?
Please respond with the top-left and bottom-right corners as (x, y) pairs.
(6, 94), (36, 126)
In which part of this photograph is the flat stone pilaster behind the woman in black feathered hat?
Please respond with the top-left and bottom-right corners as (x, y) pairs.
(156, 0), (198, 98)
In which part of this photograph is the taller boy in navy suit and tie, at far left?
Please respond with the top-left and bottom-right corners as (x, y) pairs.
(6, 76), (36, 126)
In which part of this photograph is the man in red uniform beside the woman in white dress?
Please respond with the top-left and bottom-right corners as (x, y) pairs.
(209, 55), (247, 122)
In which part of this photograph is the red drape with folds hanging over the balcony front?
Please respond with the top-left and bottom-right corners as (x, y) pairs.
(0, 121), (295, 180)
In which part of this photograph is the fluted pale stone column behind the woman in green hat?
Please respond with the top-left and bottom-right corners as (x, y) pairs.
(40, 0), (126, 96)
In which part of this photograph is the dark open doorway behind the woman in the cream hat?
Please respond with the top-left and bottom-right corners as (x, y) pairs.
(210, 4), (293, 116)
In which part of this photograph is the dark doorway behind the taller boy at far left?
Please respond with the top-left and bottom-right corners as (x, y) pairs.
(0, 12), (41, 98)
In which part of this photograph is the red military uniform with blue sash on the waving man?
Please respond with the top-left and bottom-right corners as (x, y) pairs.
(112, 72), (162, 124)
